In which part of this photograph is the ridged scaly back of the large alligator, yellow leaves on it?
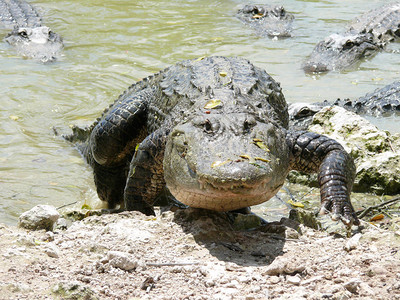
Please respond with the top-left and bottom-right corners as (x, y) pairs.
(148, 56), (288, 131)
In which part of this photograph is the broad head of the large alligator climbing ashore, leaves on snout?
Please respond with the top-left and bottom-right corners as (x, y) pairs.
(164, 113), (289, 211)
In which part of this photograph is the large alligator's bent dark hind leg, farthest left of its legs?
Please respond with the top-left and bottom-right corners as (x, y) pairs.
(82, 90), (151, 209)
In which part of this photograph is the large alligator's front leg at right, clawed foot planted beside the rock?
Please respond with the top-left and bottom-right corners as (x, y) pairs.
(287, 131), (360, 226)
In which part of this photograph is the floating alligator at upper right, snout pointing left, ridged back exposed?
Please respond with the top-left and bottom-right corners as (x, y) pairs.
(302, 3), (400, 73)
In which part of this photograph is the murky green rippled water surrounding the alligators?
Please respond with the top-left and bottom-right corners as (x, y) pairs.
(0, 0), (400, 224)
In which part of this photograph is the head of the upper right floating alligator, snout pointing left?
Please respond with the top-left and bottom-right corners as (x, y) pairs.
(302, 31), (379, 73)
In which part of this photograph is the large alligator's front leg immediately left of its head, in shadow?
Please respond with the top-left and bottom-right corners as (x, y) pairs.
(124, 129), (168, 215)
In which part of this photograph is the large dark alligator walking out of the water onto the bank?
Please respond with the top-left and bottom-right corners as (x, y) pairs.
(65, 56), (359, 225)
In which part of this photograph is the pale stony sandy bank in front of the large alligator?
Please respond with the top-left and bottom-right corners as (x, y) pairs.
(0, 209), (400, 299)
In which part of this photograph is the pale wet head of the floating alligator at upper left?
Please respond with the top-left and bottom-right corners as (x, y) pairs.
(5, 26), (63, 62)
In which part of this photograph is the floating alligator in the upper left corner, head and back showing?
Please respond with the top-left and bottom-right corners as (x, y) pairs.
(0, 0), (63, 62)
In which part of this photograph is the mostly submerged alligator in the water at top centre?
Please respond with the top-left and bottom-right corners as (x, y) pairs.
(236, 5), (294, 38)
